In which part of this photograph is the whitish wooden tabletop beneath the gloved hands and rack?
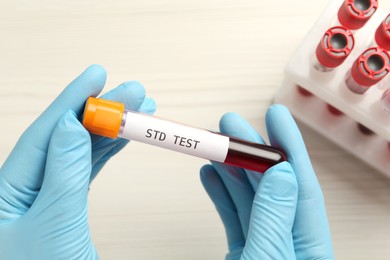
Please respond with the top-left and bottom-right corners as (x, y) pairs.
(0, 0), (390, 259)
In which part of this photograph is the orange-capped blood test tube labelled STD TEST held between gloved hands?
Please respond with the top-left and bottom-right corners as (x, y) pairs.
(83, 97), (286, 173)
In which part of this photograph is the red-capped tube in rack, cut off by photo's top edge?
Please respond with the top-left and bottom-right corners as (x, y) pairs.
(337, 0), (378, 30)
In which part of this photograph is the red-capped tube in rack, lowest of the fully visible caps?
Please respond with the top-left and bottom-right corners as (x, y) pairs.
(345, 47), (390, 94)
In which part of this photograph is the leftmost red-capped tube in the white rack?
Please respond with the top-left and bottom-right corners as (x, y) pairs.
(314, 26), (355, 72)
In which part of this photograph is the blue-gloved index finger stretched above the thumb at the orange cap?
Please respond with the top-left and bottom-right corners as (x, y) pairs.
(0, 65), (106, 220)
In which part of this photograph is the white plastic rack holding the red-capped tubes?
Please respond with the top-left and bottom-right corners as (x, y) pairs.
(274, 0), (390, 177)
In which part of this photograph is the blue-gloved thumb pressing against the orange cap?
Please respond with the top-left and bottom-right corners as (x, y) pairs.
(0, 111), (97, 260)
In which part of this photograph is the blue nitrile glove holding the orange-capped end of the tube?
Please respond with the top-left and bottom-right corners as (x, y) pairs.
(0, 65), (155, 260)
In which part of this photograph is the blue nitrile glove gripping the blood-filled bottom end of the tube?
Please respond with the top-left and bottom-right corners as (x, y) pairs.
(201, 105), (333, 259)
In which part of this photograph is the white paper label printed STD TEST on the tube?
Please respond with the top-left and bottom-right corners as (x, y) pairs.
(120, 112), (229, 162)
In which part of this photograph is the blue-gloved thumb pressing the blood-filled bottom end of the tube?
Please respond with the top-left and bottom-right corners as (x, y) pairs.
(242, 162), (298, 259)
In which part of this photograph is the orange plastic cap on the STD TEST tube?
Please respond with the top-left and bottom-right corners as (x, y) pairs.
(83, 97), (125, 138)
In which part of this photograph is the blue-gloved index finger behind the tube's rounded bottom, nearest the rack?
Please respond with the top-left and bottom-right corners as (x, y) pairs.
(266, 105), (334, 259)
